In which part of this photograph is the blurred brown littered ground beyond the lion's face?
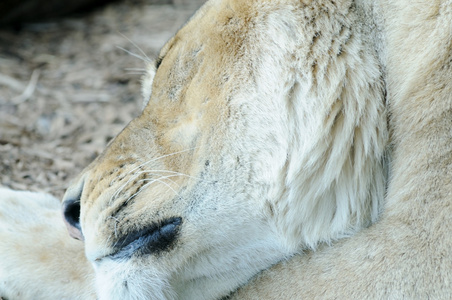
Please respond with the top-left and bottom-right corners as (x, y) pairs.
(0, 0), (204, 198)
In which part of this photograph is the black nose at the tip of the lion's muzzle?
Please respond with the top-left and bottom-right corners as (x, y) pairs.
(63, 179), (84, 241)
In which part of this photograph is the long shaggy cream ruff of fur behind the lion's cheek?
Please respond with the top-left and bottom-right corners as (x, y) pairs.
(268, 1), (387, 249)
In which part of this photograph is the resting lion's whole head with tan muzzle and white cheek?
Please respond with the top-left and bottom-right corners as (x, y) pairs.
(64, 1), (385, 299)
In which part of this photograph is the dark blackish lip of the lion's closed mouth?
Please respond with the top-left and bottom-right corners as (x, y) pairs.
(108, 217), (182, 260)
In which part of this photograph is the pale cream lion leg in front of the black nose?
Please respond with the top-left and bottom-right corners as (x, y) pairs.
(0, 188), (96, 300)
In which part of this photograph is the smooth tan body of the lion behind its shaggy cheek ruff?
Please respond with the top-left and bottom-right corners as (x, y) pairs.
(231, 1), (452, 299)
